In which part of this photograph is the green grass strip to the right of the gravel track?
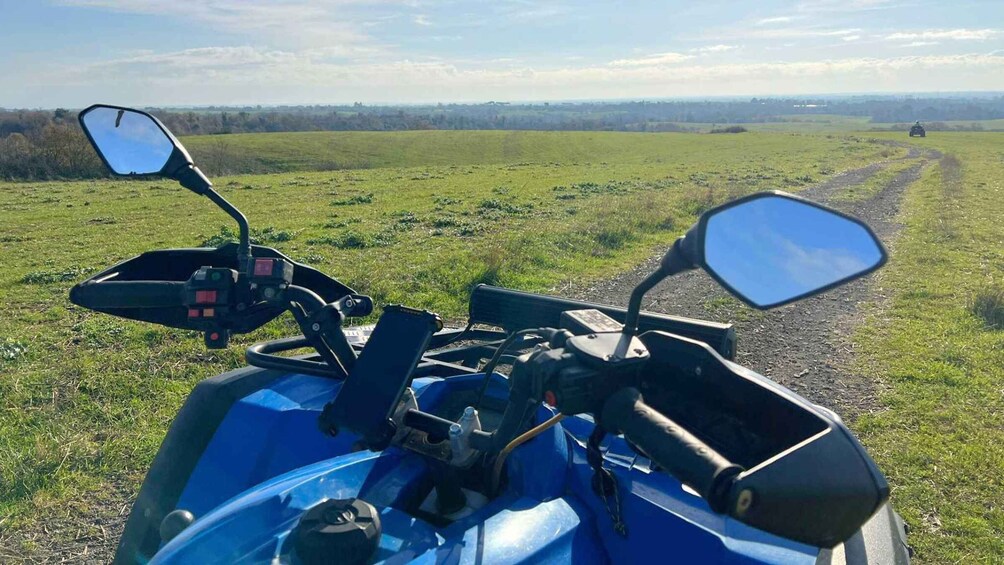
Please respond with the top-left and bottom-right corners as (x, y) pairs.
(854, 133), (1004, 563)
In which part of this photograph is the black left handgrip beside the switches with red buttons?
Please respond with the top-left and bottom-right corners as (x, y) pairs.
(69, 281), (185, 310)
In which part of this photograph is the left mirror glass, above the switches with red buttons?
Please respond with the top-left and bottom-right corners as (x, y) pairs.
(82, 106), (175, 175)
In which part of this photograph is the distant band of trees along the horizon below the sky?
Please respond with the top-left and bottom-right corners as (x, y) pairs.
(0, 95), (1004, 180)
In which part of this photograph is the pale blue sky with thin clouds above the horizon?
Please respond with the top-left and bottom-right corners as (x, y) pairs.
(0, 0), (1004, 108)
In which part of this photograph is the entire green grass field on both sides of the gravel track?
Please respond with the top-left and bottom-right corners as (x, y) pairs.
(0, 124), (1004, 562)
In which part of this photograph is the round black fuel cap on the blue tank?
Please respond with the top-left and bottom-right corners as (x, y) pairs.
(290, 499), (381, 565)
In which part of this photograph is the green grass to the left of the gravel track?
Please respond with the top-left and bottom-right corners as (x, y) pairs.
(0, 131), (887, 541)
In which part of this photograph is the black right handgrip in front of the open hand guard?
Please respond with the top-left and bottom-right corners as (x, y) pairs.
(600, 387), (743, 513)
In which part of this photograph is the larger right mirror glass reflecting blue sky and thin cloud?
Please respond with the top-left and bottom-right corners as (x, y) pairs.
(704, 195), (885, 308)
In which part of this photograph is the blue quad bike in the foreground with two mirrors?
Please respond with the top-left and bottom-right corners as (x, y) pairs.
(70, 105), (909, 564)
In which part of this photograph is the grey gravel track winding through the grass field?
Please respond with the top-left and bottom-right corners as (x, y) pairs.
(571, 149), (940, 417)
